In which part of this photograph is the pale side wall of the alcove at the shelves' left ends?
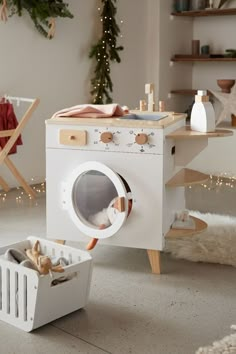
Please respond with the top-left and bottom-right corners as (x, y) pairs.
(157, 0), (193, 112)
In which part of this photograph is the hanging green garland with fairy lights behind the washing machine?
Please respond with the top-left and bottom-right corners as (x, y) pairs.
(89, 0), (123, 104)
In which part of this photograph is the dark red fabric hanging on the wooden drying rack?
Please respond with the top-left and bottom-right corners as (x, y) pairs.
(0, 101), (23, 154)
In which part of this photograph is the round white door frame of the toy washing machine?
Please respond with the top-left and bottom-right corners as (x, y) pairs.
(65, 161), (128, 239)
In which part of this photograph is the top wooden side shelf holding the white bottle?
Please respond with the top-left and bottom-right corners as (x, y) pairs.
(166, 126), (233, 139)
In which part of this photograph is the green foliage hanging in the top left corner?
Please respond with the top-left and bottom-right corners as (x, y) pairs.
(0, 0), (73, 39)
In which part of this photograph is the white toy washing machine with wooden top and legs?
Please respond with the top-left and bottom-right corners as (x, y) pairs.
(46, 112), (185, 273)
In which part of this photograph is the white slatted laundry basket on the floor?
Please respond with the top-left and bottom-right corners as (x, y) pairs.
(0, 237), (92, 332)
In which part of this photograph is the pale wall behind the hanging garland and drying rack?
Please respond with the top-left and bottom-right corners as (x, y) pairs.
(0, 0), (151, 186)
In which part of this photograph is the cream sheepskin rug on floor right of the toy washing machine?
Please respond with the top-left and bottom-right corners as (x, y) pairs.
(165, 211), (236, 267)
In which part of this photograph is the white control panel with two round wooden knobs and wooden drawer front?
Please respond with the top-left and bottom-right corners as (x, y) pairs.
(47, 125), (164, 155)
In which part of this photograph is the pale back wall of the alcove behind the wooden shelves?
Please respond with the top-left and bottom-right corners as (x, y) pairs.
(189, 0), (236, 175)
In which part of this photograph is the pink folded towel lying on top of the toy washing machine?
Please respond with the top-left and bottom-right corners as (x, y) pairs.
(52, 103), (126, 118)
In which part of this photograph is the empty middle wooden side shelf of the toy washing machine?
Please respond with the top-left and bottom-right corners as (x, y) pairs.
(166, 168), (209, 187)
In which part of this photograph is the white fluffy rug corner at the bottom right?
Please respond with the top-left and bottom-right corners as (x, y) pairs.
(196, 326), (236, 354)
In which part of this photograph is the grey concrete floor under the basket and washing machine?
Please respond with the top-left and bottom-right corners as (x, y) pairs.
(0, 190), (236, 354)
